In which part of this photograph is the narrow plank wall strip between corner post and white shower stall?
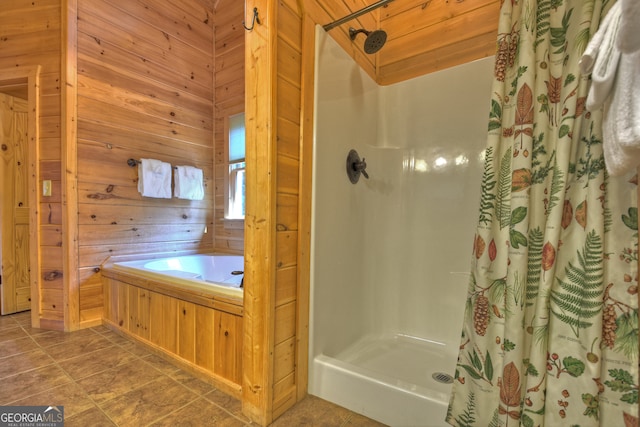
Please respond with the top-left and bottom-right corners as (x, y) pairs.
(273, 0), (306, 419)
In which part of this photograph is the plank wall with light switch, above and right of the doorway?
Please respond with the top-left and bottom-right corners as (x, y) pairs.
(0, 0), (64, 329)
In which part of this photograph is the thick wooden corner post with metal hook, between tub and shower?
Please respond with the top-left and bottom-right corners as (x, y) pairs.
(242, 0), (278, 425)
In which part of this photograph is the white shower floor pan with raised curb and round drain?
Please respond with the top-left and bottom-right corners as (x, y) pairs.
(309, 335), (457, 427)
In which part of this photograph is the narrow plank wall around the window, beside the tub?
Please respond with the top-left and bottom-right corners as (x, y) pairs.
(213, 0), (250, 254)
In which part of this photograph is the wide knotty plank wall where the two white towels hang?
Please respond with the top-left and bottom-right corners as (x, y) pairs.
(72, 0), (214, 326)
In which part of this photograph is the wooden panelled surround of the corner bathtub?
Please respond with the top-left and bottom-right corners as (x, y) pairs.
(100, 254), (243, 398)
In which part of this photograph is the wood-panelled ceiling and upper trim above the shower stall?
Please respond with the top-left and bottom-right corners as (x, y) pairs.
(316, 0), (501, 85)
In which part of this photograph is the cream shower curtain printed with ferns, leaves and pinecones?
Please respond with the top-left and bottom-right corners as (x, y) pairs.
(447, 0), (639, 427)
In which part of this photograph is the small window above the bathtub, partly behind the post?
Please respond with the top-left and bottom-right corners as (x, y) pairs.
(225, 113), (246, 219)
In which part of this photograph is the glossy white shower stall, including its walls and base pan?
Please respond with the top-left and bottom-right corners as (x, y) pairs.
(309, 27), (493, 426)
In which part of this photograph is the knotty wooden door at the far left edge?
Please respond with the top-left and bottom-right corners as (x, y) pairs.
(0, 89), (31, 314)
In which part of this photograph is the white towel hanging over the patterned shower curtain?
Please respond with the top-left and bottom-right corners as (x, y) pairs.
(580, 2), (640, 176)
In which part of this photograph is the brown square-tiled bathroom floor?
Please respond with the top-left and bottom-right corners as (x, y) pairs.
(0, 312), (382, 427)
